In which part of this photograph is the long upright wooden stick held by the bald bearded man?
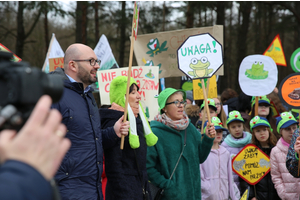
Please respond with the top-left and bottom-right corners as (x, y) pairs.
(120, 2), (139, 149)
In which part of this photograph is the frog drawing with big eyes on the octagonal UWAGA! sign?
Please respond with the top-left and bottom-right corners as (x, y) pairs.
(188, 57), (214, 78)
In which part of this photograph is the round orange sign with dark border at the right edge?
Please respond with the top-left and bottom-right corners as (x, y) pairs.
(278, 73), (300, 109)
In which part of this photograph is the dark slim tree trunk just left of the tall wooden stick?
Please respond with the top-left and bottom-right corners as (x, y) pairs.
(118, 1), (126, 67)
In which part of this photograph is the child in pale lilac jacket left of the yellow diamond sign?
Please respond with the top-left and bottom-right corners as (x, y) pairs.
(200, 117), (240, 200)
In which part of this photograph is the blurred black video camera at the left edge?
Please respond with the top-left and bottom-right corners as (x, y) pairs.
(0, 51), (63, 131)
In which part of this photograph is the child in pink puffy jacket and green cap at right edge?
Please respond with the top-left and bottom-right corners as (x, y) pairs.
(270, 112), (300, 200)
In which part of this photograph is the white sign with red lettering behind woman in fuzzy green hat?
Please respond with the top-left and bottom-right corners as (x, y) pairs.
(97, 66), (159, 120)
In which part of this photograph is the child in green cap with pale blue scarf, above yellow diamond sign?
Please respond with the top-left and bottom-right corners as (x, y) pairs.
(221, 110), (252, 194)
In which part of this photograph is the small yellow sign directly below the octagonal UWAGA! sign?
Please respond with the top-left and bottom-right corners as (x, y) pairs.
(193, 75), (218, 100)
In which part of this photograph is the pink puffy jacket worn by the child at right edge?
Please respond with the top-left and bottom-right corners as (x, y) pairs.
(270, 138), (300, 200)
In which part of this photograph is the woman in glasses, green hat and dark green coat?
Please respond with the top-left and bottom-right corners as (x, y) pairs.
(146, 88), (216, 200)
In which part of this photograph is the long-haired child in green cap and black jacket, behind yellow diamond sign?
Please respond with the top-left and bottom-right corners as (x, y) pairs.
(248, 116), (280, 200)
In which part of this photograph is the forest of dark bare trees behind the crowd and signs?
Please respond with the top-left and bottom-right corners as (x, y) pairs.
(0, 1), (300, 93)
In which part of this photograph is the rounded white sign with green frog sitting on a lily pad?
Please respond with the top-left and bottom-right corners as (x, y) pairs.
(239, 55), (278, 96)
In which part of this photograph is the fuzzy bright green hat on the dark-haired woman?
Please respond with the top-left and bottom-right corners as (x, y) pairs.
(109, 76), (138, 108)
